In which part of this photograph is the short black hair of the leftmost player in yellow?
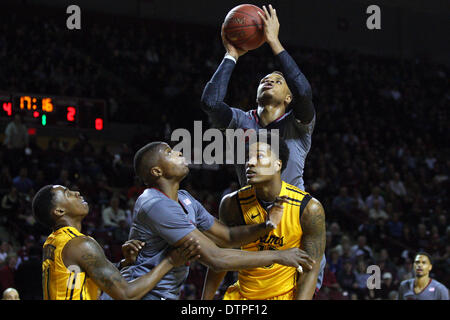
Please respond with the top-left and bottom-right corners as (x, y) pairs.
(31, 185), (55, 229)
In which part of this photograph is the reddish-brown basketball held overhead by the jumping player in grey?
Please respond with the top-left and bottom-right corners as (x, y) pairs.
(224, 4), (265, 50)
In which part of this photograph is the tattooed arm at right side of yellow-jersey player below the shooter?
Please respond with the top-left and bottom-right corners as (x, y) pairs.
(296, 198), (326, 300)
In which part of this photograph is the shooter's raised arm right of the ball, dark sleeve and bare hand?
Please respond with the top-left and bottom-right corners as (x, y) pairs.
(260, 5), (315, 124)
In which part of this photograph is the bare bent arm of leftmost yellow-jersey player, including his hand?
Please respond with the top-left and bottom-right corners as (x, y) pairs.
(62, 237), (198, 300)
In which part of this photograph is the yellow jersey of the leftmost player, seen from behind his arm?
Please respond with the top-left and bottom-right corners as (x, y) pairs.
(42, 227), (100, 300)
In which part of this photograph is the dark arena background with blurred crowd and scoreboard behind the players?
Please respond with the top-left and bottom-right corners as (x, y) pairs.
(0, 0), (450, 300)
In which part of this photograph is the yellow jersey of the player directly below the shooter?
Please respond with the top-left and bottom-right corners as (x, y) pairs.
(224, 181), (311, 300)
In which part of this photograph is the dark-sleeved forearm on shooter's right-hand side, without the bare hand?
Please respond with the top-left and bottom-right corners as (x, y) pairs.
(276, 50), (315, 123)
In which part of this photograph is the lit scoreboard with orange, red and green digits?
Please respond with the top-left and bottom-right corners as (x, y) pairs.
(0, 93), (106, 131)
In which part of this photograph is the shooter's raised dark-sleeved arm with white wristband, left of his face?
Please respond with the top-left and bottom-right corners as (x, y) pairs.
(201, 26), (246, 128)
